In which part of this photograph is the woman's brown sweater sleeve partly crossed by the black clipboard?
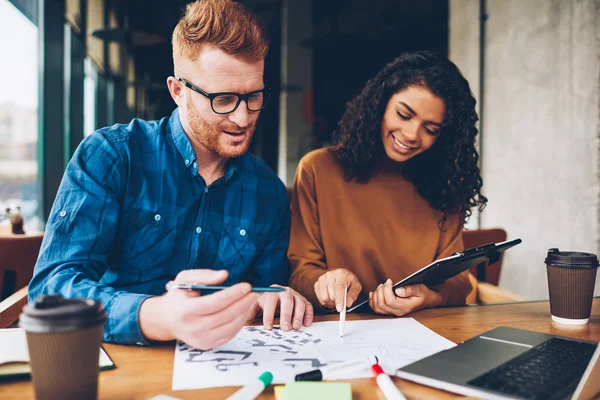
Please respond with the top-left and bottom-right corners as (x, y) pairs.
(432, 215), (473, 306)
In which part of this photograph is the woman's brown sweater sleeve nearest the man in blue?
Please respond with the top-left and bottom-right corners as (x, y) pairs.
(288, 161), (328, 311)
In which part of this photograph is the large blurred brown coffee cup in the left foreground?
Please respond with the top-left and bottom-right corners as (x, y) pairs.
(19, 295), (106, 400)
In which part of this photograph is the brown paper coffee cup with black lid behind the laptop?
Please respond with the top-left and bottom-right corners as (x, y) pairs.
(546, 249), (598, 325)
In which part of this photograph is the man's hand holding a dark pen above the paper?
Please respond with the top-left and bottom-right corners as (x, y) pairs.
(139, 269), (257, 350)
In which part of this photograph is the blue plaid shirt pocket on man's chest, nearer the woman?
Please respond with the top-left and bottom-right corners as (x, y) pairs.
(216, 222), (263, 281)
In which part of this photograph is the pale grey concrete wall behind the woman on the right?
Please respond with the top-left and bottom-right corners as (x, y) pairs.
(450, 0), (600, 299)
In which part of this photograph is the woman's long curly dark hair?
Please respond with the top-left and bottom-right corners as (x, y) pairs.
(334, 51), (487, 227)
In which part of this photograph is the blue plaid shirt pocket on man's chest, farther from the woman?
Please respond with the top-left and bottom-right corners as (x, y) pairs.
(121, 208), (177, 282)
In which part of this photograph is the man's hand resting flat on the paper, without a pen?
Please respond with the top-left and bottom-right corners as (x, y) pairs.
(252, 285), (314, 332)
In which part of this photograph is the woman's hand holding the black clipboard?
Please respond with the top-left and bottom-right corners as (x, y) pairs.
(369, 279), (442, 317)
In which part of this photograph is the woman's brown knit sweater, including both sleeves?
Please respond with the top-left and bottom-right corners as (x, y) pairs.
(288, 148), (471, 310)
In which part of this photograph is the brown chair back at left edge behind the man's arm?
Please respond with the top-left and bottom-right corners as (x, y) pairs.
(0, 234), (44, 300)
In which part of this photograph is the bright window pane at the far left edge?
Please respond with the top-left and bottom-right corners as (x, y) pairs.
(0, 0), (40, 232)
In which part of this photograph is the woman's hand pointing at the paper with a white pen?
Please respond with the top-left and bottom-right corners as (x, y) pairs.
(315, 268), (362, 312)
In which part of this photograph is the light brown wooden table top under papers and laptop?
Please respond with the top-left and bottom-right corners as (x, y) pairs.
(0, 298), (600, 400)
